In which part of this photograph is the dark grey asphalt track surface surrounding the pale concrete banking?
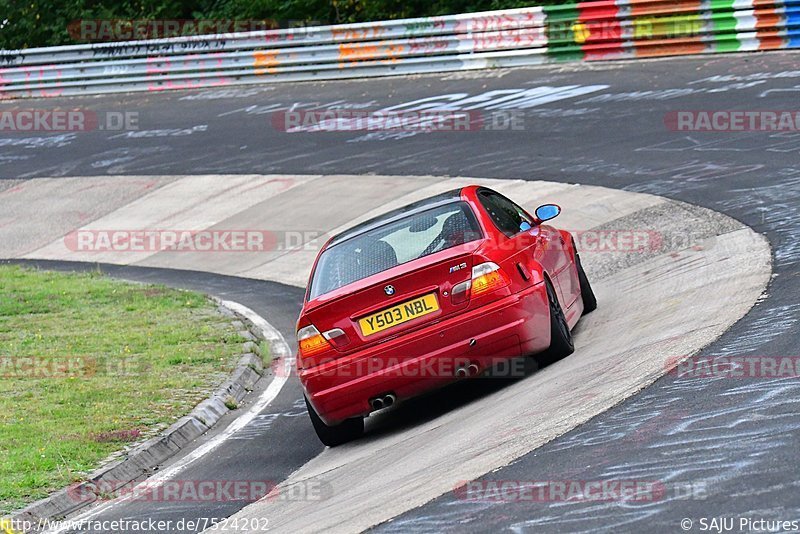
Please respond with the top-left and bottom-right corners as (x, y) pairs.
(0, 49), (800, 532)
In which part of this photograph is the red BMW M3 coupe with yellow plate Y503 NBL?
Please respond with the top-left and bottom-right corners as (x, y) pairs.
(297, 186), (597, 446)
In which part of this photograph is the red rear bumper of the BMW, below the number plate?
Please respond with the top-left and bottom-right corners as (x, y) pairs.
(299, 284), (550, 424)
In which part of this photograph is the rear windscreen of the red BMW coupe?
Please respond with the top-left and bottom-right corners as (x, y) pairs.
(309, 202), (483, 299)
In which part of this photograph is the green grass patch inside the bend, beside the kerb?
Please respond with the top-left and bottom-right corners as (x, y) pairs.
(0, 266), (243, 515)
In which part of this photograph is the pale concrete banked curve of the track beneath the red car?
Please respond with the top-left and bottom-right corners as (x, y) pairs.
(0, 175), (771, 532)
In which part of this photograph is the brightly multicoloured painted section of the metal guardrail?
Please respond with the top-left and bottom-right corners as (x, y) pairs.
(544, 0), (800, 60)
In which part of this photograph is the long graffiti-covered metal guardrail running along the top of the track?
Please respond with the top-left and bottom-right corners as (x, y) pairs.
(0, 0), (800, 99)
